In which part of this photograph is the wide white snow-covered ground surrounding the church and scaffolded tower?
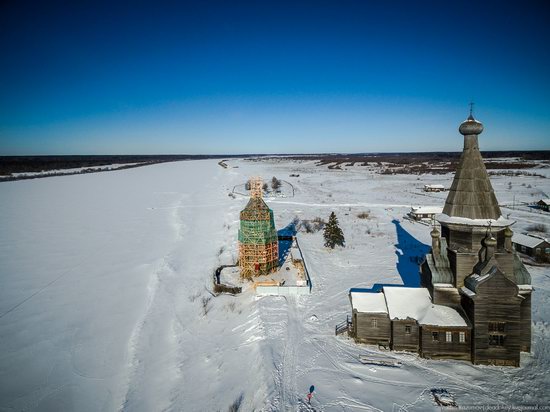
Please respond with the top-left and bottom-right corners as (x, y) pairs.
(0, 160), (550, 411)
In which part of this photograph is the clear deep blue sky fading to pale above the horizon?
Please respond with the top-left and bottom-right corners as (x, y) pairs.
(0, 0), (550, 155)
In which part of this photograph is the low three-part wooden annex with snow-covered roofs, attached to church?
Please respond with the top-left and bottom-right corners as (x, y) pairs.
(350, 286), (471, 360)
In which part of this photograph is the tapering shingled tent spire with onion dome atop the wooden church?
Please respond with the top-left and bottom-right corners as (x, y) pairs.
(443, 115), (501, 220)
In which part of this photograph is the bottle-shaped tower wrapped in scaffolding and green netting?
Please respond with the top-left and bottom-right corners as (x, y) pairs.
(239, 178), (279, 278)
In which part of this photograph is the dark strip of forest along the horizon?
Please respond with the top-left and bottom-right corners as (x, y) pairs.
(0, 150), (550, 176)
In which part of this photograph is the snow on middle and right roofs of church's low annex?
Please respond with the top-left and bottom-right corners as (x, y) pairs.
(383, 287), (467, 326)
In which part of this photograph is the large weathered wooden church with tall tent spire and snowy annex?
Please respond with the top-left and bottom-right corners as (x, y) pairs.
(350, 112), (532, 366)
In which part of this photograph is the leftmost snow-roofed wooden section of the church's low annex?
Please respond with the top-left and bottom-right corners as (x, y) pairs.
(349, 292), (391, 346)
